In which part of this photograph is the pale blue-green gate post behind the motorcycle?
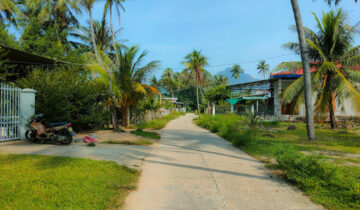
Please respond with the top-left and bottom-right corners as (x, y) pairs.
(19, 89), (36, 139)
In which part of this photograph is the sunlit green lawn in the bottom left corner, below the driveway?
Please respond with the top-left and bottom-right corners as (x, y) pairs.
(0, 154), (139, 209)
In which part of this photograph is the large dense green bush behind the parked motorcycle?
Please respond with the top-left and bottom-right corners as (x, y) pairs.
(17, 70), (108, 131)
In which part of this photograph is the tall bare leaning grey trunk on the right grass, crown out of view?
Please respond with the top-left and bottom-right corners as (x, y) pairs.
(290, 0), (315, 141)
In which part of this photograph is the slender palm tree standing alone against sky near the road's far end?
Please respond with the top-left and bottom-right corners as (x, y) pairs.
(182, 50), (208, 117)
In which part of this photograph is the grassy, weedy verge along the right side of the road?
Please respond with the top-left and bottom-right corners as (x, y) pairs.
(195, 115), (360, 209)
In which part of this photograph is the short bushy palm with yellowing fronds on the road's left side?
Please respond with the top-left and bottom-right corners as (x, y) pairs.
(113, 46), (159, 126)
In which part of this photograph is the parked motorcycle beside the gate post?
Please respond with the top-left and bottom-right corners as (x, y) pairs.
(25, 114), (75, 145)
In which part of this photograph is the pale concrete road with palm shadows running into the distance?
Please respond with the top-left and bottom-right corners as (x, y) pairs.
(125, 114), (321, 210)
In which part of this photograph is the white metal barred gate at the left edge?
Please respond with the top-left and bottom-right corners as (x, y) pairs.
(0, 83), (21, 142)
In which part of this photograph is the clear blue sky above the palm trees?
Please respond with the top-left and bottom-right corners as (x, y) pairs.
(86, 0), (360, 78)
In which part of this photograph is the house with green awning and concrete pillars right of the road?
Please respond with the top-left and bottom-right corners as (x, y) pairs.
(227, 67), (360, 120)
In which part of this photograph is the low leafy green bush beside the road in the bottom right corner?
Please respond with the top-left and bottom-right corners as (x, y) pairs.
(276, 149), (360, 209)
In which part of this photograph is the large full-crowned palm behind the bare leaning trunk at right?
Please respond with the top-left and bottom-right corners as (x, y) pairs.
(275, 10), (360, 128)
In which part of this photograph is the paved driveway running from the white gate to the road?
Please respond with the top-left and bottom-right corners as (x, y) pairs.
(0, 141), (152, 168)
